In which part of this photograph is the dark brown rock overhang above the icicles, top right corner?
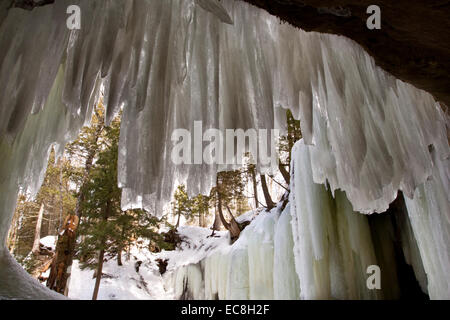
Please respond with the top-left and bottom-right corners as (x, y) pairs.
(244, 0), (450, 106)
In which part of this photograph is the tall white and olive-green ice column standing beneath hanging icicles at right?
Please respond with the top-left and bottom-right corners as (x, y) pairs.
(290, 141), (384, 299)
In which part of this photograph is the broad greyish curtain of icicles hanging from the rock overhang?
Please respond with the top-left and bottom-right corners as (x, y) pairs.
(0, 0), (449, 218)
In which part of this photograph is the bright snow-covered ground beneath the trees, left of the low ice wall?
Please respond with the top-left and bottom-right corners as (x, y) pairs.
(69, 220), (248, 300)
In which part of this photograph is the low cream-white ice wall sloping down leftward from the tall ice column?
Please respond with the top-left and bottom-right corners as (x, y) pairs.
(171, 208), (292, 300)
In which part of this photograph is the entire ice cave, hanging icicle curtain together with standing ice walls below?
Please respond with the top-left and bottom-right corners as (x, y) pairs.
(0, 0), (450, 299)
